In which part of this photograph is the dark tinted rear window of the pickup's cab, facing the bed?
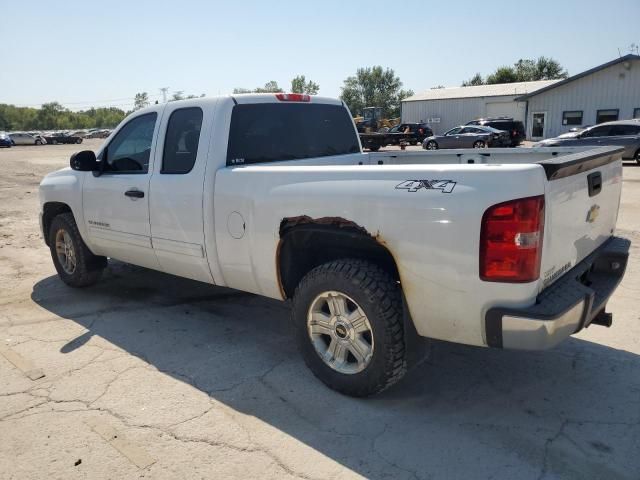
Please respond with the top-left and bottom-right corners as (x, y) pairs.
(227, 103), (360, 166)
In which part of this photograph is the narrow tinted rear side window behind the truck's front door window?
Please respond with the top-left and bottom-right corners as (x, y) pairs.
(160, 107), (202, 174)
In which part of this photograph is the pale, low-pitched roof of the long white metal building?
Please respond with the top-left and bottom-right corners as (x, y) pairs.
(403, 80), (559, 102)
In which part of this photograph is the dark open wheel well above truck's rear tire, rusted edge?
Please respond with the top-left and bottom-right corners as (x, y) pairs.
(276, 216), (400, 298)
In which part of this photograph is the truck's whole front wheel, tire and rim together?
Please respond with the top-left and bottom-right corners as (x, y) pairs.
(49, 213), (107, 287)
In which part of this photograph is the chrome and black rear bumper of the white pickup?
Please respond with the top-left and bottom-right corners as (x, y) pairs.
(485, 237), (631, 350)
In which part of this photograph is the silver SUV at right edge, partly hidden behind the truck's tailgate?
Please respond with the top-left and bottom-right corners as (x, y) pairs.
(533, 119), (640, 163)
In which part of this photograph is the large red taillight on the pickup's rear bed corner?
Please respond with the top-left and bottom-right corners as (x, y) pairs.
(480, 195), (544, 283)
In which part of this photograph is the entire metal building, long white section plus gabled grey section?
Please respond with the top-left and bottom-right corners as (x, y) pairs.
(402, 55), (640, 140)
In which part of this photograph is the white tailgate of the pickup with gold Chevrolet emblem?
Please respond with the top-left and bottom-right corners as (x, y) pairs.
(539, 147), (623, 290)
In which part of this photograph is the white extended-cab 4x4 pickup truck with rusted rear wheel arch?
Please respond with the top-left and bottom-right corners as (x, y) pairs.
(40, 94), (629, 396)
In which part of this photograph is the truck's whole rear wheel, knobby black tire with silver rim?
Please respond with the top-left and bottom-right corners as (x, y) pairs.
(292, 259), (407, 397)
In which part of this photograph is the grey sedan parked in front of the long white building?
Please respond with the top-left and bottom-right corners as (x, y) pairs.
(422, 125), (511, 150)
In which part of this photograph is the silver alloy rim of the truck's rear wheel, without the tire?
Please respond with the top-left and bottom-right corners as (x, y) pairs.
(307, 291), (374, 375)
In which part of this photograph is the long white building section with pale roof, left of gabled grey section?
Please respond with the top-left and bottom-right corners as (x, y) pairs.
(402, 80), (557, 134)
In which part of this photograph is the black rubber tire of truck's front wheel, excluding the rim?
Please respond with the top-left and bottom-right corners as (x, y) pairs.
(49, 213), (107, 287)
